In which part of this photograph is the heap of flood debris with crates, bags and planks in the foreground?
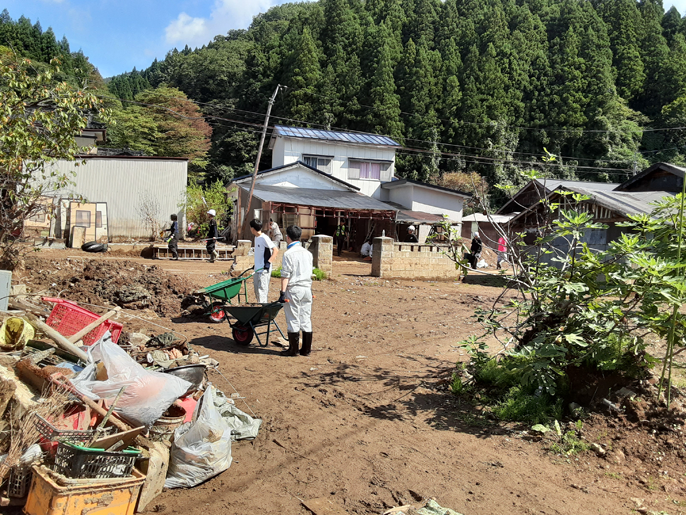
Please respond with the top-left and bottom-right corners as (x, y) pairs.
(0, 292), (262, 515)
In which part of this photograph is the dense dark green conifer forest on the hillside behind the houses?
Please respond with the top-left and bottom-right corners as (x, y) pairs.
(105, 0), (686, 196)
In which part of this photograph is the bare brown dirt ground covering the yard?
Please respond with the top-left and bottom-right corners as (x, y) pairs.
(13, 251), (686, 515)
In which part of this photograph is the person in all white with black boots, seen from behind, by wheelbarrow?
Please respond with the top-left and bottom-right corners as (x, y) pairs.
(279, 225), (312, 356)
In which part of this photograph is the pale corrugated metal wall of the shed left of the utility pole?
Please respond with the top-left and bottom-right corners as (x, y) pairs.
(47, 157), (188, 239)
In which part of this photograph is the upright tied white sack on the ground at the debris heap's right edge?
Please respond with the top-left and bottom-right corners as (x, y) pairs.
(164, 386), (233, 488)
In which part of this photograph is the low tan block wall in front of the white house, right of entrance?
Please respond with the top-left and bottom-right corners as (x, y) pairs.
(372, 238), (460, 279)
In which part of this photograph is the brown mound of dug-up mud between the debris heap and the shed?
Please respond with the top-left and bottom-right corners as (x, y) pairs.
(18, 258), (195, 317)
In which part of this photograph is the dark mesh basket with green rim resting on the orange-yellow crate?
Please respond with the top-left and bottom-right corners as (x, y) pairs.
(55, 442), (140, 478)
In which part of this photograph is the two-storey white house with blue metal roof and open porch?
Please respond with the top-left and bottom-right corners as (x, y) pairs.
(234, 125), (469, 248)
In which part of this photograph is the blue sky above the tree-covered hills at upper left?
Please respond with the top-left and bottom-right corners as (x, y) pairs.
(3, 0), (686, 77)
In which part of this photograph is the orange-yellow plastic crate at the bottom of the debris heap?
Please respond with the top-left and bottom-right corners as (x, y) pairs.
(24, 466), (145, 515)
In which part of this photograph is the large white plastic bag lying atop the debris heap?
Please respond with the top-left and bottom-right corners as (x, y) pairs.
(72, 340), (191, 426)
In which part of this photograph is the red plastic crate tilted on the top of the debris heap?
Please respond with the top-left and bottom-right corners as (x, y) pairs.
(43, 297), (124, 345)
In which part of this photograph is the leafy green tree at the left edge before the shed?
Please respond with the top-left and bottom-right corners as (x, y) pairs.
(0, 52), (108, 269)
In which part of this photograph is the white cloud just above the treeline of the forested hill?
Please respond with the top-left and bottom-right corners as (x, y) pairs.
(165, 0), (276, 48)
